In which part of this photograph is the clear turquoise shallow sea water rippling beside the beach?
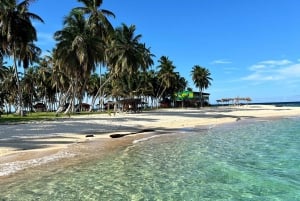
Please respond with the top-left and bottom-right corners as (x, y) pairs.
(0, 118), (300, 201)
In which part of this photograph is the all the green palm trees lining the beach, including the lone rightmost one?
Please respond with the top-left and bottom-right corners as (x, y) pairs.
(0, 0), (211, 115)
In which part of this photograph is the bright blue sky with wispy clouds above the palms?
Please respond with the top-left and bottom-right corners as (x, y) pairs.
(30, 0), (300, 103)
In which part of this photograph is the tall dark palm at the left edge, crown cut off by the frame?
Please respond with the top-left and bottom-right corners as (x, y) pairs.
(0, 0), (43, 116)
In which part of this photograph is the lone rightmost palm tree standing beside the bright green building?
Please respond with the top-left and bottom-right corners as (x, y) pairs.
(191, 65), (212, 107)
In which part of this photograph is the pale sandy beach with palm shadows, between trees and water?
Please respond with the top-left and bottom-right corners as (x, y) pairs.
(0, 105), (300, 178)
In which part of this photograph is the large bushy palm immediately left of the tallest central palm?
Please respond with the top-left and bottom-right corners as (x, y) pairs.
(54, 10), (104, 112)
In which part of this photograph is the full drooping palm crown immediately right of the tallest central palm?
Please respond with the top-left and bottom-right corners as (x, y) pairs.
(108, 24), (153, 100)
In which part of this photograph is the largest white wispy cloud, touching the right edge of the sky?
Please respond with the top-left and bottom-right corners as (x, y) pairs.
(242, 60), (300, 82)
